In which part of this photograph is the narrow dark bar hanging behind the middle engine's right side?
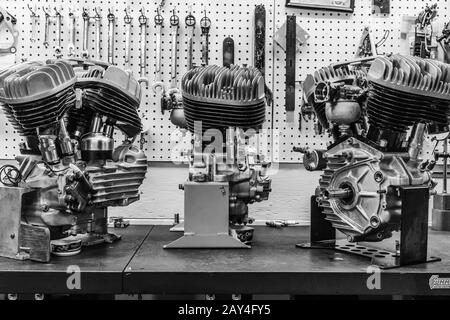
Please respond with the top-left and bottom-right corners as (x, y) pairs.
(254, 4), (273, 106)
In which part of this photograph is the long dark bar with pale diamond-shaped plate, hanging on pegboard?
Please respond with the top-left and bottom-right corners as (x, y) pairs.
(274, 15), (310, 122)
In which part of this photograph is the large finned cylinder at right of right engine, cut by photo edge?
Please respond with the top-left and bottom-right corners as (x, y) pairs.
(367, 55), (450, 132)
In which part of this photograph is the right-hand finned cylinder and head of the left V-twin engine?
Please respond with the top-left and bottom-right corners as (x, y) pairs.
(75, 65), (142, 137)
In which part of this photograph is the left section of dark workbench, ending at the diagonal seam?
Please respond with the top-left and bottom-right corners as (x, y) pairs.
(0, 226), (153, 294)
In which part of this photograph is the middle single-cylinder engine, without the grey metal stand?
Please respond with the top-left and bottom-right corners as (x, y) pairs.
(182, 65), (271, 236)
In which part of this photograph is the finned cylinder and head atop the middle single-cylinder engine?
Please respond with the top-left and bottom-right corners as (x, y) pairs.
(181, 65), (266, 132)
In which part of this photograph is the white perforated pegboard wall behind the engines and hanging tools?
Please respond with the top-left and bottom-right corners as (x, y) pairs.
(0, 0), (450, 162)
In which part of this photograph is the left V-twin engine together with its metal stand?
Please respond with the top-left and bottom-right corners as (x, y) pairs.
(0, 60), (147, 262)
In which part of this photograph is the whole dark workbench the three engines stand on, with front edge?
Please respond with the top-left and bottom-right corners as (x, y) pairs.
(0, 225), (450, 296)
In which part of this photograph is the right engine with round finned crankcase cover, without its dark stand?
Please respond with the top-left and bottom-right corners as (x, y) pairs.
(304, 55), (450, 242)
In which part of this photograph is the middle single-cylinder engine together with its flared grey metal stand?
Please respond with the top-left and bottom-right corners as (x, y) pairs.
(166, 65), (271, 248)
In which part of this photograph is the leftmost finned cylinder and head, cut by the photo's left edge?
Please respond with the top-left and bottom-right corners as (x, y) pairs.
(0, 60), (76, 136)
